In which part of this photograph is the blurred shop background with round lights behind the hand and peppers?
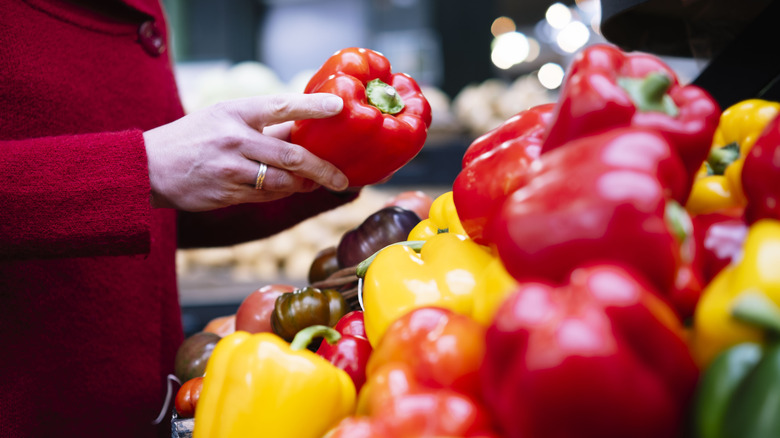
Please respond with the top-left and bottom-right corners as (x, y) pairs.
(169, 0), (699, 332)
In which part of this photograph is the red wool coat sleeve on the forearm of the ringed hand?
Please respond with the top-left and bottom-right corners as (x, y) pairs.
(0, 130), (151, 260)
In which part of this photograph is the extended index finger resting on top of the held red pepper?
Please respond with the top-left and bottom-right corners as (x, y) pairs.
(227, 93), (344, 131)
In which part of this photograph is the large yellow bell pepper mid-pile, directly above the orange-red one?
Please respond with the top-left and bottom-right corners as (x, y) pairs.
(359, 233), (493, 346)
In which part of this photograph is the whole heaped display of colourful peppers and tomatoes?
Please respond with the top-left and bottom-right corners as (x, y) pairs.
(174, 44), (780, 438)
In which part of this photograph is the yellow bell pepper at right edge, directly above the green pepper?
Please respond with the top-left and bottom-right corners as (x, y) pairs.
(692, 219), (780, 366)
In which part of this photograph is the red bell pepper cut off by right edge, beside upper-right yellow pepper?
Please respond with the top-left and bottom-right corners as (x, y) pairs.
(742, 113), (780, 224)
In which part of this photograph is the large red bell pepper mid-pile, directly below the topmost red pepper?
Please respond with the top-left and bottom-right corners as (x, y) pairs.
(487, 128), (684, 295)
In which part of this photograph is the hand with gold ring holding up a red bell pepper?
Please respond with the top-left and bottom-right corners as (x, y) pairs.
(144, 93), (348, 211)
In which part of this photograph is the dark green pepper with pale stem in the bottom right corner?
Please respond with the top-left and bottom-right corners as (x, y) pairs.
(692, 293), (780, 438)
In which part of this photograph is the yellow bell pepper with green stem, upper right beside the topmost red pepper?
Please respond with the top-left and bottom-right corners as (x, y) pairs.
(685, 99), (780, 214)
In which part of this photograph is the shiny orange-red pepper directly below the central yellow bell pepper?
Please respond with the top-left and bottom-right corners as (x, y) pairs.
(367, 307), (485, 394)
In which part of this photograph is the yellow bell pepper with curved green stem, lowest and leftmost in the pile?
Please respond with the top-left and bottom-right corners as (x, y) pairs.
(193, 331), (356, 438)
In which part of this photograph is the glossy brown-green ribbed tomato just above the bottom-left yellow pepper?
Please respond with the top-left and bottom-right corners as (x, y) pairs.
(271, 286), (349, 342)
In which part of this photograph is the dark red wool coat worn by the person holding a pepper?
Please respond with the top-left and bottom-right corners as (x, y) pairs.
(0, 0), (354, 438)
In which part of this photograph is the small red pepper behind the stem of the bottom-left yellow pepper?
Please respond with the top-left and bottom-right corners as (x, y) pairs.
(317, 310), (372, 392)
